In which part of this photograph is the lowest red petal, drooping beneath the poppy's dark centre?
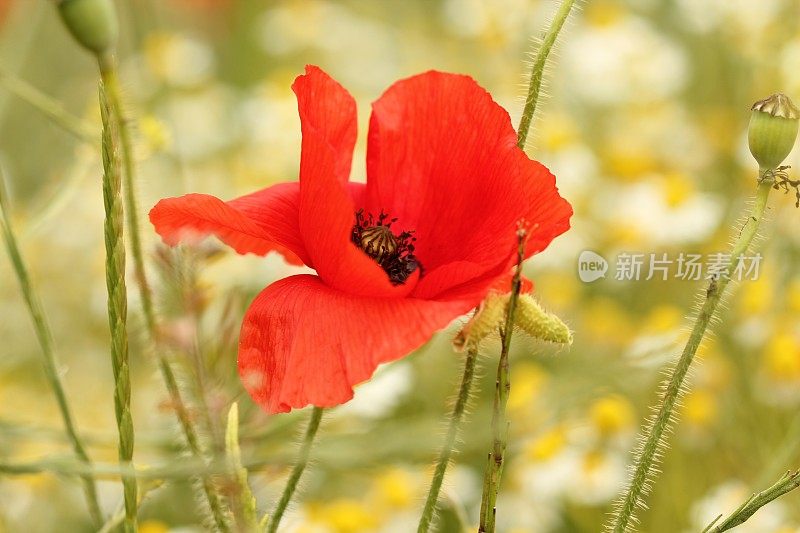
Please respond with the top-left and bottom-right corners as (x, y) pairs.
(239, 275), (473, 413)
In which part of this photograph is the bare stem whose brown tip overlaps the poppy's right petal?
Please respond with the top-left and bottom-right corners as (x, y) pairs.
(478, 229), (527, 533)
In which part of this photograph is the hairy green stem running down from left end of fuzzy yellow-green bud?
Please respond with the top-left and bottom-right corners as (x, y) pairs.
(417, 344), (478, 533)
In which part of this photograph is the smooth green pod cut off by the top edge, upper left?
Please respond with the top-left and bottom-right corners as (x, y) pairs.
(58, 0), (118, 55)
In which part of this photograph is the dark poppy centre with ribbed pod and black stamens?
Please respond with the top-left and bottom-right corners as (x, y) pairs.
(350, 209), (422, 285)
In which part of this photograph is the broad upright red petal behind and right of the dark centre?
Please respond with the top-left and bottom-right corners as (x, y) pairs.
(367, 72), (572, 297)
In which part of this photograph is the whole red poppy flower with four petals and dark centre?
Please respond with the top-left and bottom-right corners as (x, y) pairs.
(150, 66), (572, 413)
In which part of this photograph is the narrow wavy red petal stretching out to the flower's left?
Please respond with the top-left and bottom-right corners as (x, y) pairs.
(150, 183), (311, 265)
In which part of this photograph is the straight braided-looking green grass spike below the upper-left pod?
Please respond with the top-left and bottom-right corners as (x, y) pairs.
(100, 85), (138, 533)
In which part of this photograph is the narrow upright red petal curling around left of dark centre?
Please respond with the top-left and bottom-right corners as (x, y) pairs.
(292, 66), (418, 297)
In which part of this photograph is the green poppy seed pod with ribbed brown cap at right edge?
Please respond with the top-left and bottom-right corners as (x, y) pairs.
(747, 93), (800, 170)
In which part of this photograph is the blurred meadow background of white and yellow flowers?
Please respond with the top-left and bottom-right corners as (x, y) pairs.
(0, 0), (800, 533)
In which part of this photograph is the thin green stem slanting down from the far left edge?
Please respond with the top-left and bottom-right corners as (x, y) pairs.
(0, 175), (103, 526)
